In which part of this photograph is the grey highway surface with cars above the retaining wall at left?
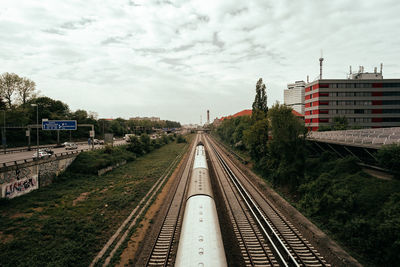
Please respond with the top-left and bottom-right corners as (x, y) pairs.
(0, 140), (126, 165)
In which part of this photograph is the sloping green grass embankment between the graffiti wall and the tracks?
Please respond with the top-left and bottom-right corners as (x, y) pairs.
(0, 138), (192, 266)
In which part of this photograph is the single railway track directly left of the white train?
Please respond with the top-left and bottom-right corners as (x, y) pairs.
(146, 137), (199, 266)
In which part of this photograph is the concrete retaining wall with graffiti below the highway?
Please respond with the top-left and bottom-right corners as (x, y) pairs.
(0, 154), (77, 198)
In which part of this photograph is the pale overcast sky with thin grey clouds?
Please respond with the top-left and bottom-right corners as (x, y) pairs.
(0, 0), (400, 123)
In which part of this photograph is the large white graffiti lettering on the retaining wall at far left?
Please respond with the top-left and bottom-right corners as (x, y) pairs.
(1, 175), (39, 198)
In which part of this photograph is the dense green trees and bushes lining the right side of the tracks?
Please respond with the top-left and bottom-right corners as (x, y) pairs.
(213, 79), (400, 266)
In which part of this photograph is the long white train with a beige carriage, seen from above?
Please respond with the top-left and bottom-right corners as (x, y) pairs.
(175, 142), (227, 267)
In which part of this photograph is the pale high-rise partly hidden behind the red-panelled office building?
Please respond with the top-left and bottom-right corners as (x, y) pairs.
(283, 81), (306, 114)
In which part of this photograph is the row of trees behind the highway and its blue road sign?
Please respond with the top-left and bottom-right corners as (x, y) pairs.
(0, 72), (181, 147)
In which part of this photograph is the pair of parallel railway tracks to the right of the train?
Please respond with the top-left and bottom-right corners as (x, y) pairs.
(206, 138), (330, 266)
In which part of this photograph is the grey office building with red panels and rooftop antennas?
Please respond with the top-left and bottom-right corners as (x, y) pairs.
(305, 74), (400, 131)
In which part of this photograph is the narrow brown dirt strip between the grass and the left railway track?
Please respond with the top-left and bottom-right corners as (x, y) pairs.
(115, 160), (183, 267)
